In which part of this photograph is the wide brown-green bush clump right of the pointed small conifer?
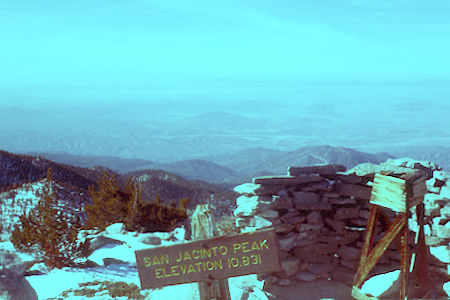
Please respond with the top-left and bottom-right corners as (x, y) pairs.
(84, 172), (189, 232)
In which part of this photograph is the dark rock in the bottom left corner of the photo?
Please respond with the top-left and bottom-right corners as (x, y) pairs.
(0, 249), (38, 300)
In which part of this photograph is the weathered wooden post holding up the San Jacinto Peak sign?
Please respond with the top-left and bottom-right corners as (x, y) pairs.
(191, 204), (231, 300)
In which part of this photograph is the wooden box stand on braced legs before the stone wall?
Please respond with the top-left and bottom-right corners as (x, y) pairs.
(352, 168), (428, 300)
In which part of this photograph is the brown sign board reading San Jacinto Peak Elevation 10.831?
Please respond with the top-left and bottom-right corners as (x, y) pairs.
(135, 230), (281, 289)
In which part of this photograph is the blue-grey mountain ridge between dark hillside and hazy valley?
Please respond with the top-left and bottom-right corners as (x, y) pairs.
(27, 146), (393, 187)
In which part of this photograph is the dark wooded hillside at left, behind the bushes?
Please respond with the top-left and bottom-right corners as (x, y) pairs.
(0, 151), (235, 217)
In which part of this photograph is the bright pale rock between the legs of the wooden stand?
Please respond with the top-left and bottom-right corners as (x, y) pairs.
(361, 270), (400, 298)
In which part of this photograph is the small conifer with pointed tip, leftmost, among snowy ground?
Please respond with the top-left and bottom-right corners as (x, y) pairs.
(11, 169), (83, 268)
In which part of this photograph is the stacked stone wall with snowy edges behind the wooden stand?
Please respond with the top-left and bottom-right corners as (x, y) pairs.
(234, 159), (450, 292)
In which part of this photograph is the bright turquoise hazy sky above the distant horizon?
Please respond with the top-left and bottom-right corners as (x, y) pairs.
(0, 0), (450, 95)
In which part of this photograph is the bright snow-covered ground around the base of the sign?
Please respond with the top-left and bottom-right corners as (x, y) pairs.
(0, 224), (267, 300)
